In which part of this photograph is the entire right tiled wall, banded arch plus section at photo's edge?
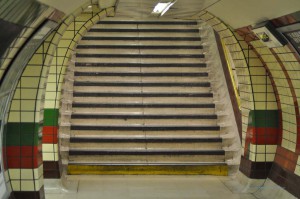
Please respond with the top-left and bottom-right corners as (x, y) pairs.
(193, 11), (300, 197)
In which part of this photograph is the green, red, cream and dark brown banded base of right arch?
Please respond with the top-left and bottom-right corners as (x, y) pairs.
(240, 110), (279, 179)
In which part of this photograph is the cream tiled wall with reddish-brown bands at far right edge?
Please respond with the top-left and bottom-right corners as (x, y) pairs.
(233, 13), (300, 197)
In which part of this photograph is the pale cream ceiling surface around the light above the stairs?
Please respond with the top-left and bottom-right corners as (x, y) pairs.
(38, 0), (300, 29)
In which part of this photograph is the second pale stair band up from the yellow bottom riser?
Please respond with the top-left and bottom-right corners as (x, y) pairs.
(70, 142), (222, 151)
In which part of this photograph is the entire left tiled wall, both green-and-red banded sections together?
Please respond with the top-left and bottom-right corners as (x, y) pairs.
(3, 3), (114, 198)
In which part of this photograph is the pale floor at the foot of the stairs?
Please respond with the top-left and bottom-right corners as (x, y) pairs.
(45, 175), (256, 199)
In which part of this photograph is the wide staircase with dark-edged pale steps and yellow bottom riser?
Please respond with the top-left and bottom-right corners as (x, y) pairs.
(62, 20), (227, 175)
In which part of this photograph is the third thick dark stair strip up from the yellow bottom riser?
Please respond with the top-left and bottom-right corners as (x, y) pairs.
(71, 125), (220, 131)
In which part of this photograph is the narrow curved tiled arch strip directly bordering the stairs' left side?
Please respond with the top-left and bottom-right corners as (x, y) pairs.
(43, 4), (113, 178)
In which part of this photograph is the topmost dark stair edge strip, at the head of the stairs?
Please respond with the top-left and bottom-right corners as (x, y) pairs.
(97, 20), (198, 25)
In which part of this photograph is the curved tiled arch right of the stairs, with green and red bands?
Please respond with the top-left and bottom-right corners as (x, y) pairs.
(195, 11), (279, 178)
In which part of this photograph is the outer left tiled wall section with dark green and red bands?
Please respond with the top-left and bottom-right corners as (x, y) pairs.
(4, 35), (51, 198)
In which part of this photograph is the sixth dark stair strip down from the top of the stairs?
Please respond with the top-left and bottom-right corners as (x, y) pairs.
(75, 61), (206, 68)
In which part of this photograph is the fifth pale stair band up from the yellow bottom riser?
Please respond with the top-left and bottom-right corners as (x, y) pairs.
(72, 107), (215, 114)
